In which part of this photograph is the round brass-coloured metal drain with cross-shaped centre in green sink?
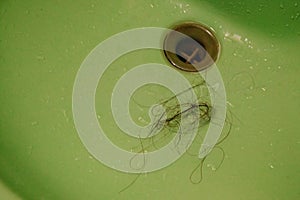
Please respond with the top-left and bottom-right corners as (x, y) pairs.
(164, 22), (220, 72)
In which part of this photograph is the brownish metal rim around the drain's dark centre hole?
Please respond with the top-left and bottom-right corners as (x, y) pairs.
(163, 22), (221, 72)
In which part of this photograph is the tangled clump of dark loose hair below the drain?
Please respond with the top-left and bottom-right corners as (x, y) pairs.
(120, 81), (232, 192)
